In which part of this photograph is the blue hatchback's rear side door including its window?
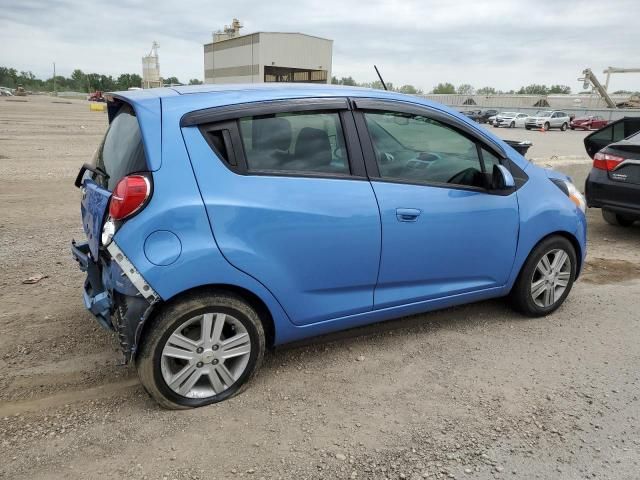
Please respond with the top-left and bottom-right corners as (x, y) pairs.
(183, 98), (380, 325)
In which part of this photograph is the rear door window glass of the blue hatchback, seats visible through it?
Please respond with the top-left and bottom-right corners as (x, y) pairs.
(239, 112), (349, 174)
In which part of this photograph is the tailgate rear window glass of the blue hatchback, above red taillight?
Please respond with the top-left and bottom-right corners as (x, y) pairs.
(94, 104), (148, 190)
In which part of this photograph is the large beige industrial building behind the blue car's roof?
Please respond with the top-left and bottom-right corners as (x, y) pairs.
(204, 19), (333, 83)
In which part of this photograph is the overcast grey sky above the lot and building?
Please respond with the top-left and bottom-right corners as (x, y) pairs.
(0, 0), (640, 92)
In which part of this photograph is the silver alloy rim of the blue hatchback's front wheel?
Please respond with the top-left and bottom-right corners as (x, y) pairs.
(530, 249), (571, 308)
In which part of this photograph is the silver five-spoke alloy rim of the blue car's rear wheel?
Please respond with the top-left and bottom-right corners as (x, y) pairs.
(160, 312), (251, 398)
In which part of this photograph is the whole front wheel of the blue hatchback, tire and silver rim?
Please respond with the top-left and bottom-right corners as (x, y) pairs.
(510, 236), (577, 317)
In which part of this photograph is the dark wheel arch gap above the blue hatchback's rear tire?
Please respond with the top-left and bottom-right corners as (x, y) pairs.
(136, 284), (276, 355)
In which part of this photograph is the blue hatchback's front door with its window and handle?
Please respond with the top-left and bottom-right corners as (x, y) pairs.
(357, 102), (519, 308)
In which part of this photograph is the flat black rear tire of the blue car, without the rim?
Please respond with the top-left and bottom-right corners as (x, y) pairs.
(136, 292), (265, 410)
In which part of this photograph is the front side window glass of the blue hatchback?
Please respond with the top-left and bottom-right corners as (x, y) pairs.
(364, 112), (485, 187)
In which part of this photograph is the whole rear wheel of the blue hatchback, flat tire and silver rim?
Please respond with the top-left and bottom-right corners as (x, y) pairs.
(136, 293), (265, 409)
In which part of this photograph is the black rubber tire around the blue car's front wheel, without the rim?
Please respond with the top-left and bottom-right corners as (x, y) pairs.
(509, 235), (577, 317)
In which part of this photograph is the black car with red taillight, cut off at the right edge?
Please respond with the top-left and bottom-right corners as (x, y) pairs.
(584, 117), (640, 227)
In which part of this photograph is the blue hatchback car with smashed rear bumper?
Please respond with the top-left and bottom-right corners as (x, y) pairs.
(72, 84), (586, 408)
